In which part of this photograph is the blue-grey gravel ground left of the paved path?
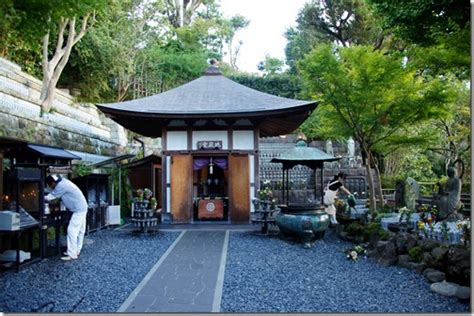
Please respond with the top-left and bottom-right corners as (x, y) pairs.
(0, 230), (179, 312)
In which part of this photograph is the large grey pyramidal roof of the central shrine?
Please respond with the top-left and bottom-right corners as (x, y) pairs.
(97, 65), (317, 137)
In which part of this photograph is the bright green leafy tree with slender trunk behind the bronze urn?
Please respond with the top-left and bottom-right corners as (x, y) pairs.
(298, 45), (452, 211)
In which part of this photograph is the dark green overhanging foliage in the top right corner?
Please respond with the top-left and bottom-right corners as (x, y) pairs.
(369, 0), (471, 79)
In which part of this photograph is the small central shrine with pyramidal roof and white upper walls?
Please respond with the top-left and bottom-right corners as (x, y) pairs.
(97, 64), (317, 223)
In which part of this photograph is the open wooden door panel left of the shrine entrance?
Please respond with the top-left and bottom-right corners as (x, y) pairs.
(171, 155), (193, 223)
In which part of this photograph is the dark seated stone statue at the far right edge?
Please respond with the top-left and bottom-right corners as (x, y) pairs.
(435, 167), (463, 221)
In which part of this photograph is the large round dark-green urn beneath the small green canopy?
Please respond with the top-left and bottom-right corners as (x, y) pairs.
(275, 204), (329, 248)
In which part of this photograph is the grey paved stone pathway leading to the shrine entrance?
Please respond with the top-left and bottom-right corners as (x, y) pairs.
(118, 230), (229, 312)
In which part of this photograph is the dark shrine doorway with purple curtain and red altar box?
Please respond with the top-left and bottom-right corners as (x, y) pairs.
(193, 156), (229, 222)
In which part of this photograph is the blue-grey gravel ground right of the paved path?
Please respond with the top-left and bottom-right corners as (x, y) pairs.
(221, 231), (470, 313)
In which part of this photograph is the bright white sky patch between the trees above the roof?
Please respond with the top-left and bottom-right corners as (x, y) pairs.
(220, 0), (307, 72)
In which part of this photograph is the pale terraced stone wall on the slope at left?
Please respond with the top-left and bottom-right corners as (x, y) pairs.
(0, 58), (161, 156)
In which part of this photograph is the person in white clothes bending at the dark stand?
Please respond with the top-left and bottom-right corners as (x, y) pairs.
(45, 175), (87, 260)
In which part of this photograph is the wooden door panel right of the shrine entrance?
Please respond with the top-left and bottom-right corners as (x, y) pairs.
(229, 155), (250, 222)
